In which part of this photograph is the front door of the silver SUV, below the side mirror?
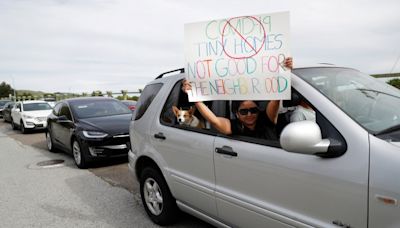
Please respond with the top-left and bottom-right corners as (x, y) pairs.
(214, 79), (369, 227)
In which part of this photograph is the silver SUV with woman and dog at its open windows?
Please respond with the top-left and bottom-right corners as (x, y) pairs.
(129, 66), (400, 227)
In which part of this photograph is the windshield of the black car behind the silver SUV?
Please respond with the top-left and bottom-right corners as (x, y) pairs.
(71, 100), (132, 119)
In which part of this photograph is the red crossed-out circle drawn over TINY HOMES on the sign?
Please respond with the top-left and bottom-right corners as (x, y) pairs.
(221, 16), (267, 59)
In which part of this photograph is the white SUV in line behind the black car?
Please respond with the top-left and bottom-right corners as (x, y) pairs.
(11, 101), (51, 134)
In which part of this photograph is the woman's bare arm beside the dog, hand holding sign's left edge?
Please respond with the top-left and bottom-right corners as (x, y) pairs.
(182, 79), (232, 135)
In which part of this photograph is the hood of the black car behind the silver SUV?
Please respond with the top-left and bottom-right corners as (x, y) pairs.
(79, 114), (132, 135)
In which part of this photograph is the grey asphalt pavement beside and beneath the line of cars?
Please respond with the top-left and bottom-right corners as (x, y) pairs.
(0, 119), (209, 227)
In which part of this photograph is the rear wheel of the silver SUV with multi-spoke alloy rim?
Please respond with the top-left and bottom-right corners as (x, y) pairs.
(140, 167), (179, 226)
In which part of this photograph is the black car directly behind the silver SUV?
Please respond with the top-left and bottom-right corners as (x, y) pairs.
(46, 97), (132, 168)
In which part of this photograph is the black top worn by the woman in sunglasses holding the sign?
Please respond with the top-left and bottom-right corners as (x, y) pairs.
(231, 112), (278, 140)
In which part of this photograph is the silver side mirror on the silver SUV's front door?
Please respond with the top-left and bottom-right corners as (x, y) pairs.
(280, 121), (330, 154)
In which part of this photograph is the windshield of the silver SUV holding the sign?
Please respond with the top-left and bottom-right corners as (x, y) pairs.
(293, 67), (400, 134)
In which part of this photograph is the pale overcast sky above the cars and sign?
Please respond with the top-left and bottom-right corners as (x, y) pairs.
(0, 0), (400, 93)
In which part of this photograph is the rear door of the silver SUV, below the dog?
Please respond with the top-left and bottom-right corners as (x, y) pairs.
(151, 82), (217, 217)
